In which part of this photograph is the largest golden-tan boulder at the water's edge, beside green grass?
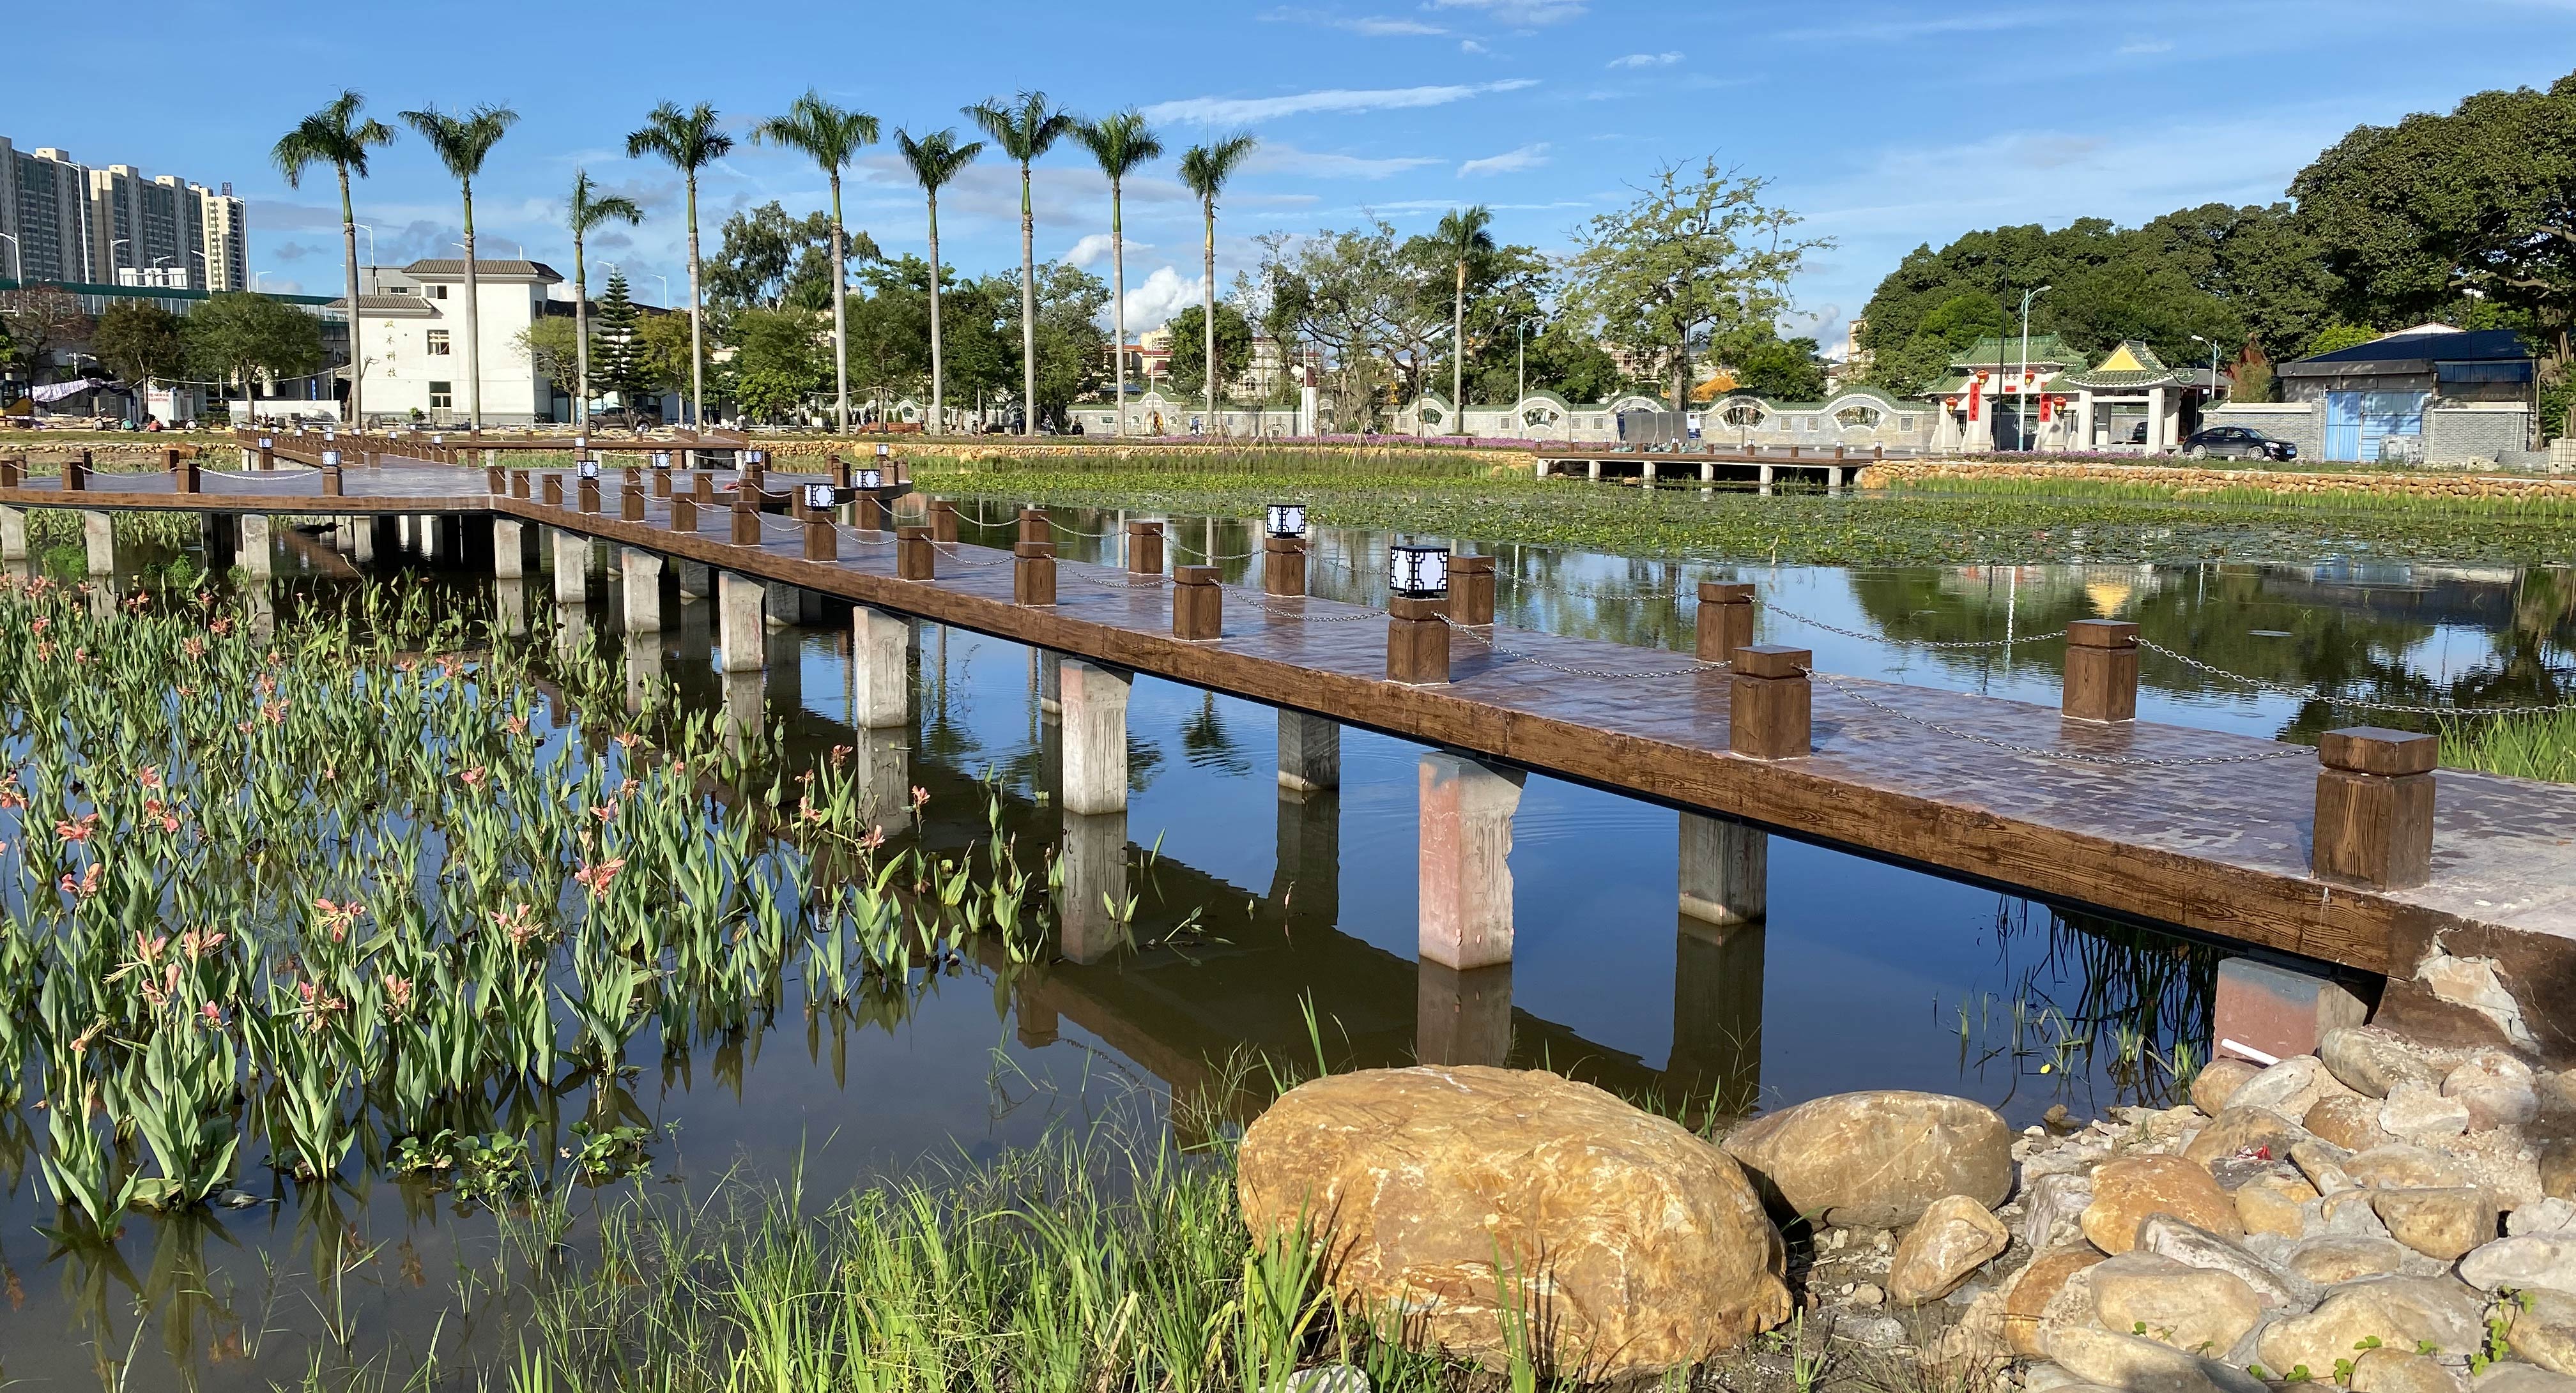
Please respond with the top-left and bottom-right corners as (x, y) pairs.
(1236, 1066), (1790, 1380)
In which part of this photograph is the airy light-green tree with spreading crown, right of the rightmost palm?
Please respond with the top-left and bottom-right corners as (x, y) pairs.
(1568, 160), (1832, 402)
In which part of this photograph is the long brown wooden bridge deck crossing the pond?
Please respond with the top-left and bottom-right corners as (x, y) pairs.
(0, 464), (2576, 989)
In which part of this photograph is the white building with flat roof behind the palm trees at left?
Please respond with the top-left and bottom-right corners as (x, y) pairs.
(332, 260), (569, 427)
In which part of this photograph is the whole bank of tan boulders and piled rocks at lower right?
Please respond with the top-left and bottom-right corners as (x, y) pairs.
(1239, 1025), (2576, 1393)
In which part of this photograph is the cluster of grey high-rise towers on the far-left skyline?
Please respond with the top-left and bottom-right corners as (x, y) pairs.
(0, 137), (250, 291)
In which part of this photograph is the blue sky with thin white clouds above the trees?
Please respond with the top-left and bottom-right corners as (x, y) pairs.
(0, 0), (2576, 353)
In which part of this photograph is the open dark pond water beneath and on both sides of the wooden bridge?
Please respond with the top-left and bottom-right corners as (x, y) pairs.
(0, 502), (2576, 1388)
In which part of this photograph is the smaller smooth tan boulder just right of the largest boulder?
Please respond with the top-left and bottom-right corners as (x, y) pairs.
(1721, 1089), (2012, 1228)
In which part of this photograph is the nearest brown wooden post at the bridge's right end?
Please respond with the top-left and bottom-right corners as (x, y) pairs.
(2308, 726), (2442, 891)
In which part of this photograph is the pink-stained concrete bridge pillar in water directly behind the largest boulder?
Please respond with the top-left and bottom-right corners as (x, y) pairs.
(1417, 752), (1530, 968)
